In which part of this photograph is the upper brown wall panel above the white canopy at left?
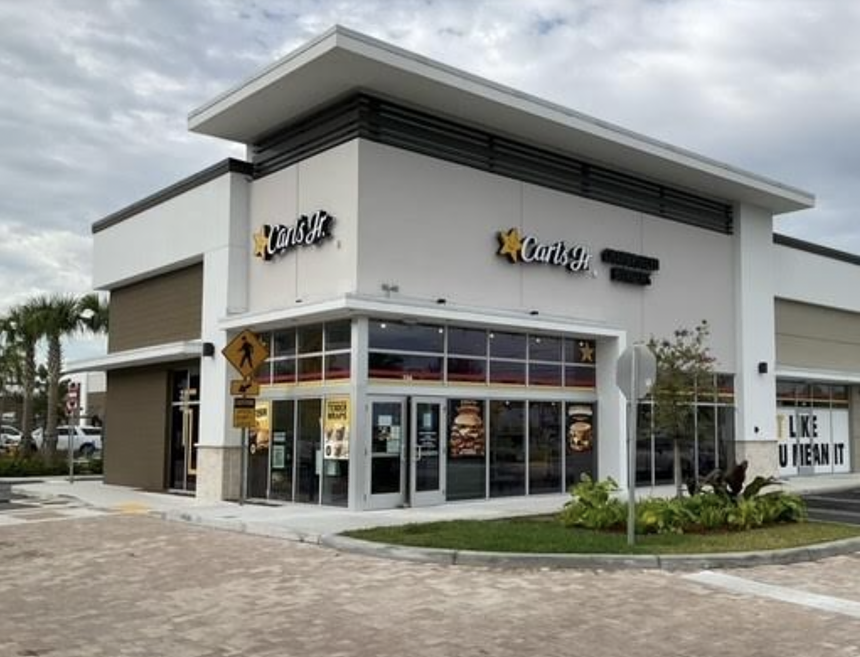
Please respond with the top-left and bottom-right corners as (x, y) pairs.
(108, 264), (203, 352)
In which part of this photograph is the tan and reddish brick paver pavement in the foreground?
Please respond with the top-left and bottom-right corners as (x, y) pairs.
(0, 515), (860, 657)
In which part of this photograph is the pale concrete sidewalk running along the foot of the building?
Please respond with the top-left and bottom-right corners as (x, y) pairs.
(13, 474), (860, 543)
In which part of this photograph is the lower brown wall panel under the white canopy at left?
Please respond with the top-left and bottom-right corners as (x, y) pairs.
(104, 367), (169, 490)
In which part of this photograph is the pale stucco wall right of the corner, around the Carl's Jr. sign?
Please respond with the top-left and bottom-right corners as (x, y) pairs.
(357, 141), (736, 371)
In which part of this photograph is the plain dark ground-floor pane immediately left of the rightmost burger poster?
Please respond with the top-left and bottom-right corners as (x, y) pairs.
(529, 402), (562, 493)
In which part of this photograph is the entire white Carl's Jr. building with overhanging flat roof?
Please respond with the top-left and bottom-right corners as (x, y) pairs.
(72, 28), (860, 509)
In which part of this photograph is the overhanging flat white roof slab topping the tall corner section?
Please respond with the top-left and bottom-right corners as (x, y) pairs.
(188, 26), (815, 214)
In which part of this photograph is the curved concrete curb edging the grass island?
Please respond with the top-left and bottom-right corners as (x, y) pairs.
(319, 534), (860, 571)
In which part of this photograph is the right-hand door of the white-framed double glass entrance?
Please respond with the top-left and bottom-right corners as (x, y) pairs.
(409, 397), (447, 506)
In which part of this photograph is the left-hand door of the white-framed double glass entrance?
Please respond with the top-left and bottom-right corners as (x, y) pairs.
(369, 397), (407, 509)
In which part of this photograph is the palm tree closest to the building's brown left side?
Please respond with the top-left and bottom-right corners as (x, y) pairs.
(34, 294), (107, 456)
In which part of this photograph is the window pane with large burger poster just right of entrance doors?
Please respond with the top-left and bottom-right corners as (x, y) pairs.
(446, 399), (487, 500)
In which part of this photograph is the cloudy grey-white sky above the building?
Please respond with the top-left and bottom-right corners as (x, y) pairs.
(0, 0), (860, 356)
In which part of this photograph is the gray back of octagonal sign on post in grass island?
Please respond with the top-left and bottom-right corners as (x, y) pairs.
(615, 344), (657, 545)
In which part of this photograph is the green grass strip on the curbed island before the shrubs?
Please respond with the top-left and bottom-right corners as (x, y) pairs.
(345, 516), (860, 554)
